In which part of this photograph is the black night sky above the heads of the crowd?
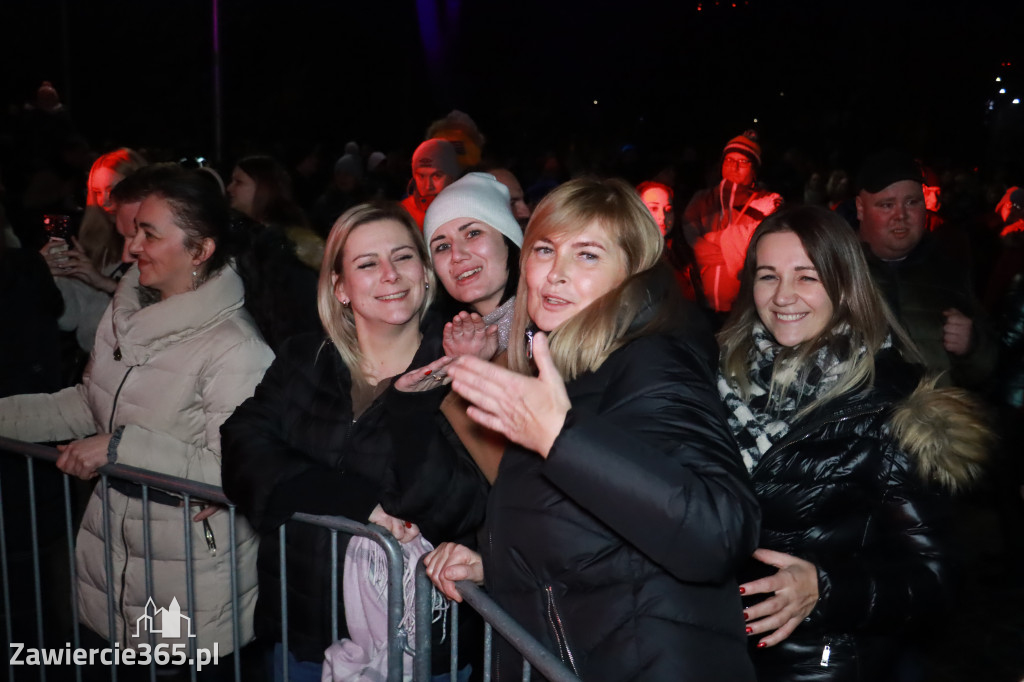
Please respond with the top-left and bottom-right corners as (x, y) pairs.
(0, 0), (1024, 173)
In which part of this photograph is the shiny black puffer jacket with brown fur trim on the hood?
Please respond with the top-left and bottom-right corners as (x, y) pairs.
(744, 350), (986, 682)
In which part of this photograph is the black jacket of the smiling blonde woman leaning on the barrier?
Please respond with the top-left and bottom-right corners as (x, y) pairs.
(221, 329), (486, 660)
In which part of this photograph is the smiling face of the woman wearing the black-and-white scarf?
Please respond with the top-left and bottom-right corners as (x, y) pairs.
(754, 232), (833, 348)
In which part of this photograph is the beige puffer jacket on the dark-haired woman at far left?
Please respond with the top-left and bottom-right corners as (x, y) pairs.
(0, 261), (273, 655)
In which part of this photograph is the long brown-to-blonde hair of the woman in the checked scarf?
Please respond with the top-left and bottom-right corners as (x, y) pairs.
(718, 201), (919, 418)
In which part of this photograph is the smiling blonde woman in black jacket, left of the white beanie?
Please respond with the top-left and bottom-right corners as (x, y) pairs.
(221, 204), (486, 680)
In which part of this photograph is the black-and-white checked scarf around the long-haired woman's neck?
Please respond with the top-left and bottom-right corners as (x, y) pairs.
(718, 323), (868, 471)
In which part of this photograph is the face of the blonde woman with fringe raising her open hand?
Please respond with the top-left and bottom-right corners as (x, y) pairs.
(523, 222), (627, 332)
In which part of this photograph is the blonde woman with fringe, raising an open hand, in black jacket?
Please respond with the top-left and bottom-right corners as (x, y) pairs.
(427, 179), (758, 681)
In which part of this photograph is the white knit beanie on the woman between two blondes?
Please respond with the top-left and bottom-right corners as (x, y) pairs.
(423, 173), (522, 257)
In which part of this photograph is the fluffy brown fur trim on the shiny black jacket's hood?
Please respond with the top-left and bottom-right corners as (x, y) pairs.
(889, 377), (994, 493)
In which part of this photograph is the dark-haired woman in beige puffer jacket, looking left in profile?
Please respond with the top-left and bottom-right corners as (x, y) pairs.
(0, 169), (273, 655)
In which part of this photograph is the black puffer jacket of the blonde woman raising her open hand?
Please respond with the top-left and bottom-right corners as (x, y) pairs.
(482, 296), (758, 682)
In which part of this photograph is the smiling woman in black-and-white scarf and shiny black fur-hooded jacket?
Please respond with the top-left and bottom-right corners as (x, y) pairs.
(719, 206), (987, 682)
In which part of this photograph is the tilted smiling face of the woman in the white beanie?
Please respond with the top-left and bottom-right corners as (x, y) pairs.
(428, 218), (509, 315)
